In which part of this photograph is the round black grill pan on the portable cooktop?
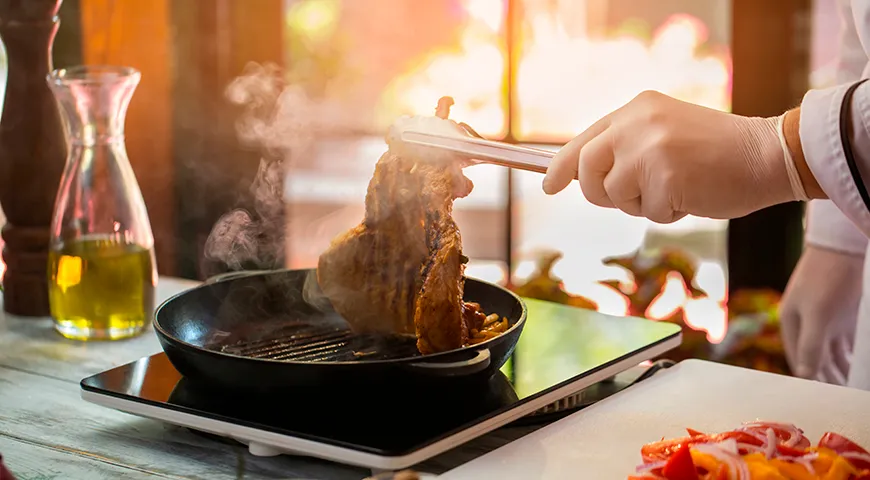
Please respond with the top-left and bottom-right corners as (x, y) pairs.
(154, 269), (526, 390)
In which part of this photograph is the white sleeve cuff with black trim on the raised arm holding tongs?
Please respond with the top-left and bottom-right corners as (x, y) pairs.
(800, 83), (870, 237)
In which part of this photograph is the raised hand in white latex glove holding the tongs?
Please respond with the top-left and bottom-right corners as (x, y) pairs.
(543, 92), (806, 223)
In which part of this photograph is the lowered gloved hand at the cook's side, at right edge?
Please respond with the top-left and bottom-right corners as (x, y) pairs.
(780, 245), (864, 385)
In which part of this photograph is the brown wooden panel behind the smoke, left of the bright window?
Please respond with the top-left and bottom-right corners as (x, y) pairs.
(171, 0), (284, 278)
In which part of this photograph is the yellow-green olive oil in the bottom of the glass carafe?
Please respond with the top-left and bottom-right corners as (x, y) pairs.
(48, 236), (156, 340)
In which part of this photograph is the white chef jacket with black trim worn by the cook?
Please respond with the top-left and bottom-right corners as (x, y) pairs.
(800, 0), (870, 390)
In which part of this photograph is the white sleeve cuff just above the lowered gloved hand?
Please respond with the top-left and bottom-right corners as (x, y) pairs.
(804, 200), (868, 257)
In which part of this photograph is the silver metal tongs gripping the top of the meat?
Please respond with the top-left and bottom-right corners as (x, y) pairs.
(402, 123), (555, 173)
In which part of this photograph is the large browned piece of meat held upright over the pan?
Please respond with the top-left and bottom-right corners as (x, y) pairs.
(317, 116), (480, 354)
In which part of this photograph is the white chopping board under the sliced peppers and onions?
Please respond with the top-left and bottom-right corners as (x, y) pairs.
(439, 360), (870, 480)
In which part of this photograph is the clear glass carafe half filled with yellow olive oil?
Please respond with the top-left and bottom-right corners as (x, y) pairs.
(47, 66), (157, 340)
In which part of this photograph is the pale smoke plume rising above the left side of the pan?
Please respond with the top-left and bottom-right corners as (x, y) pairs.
(204, 63), (350, 271)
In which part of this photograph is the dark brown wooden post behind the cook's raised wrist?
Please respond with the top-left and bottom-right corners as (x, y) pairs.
(728, 0), (811, 292)
